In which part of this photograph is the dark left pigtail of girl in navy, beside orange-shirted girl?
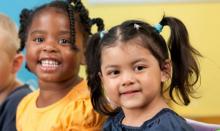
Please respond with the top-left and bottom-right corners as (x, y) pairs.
(85, 33), (117, 115)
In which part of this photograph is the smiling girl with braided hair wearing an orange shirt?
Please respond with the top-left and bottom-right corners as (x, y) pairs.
(16, 0), (105, 131)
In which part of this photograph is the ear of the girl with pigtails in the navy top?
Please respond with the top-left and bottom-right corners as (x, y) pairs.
(161, 59), (172, 82)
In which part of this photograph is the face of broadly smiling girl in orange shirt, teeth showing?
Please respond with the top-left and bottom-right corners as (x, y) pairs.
(26, 7), (83, 82)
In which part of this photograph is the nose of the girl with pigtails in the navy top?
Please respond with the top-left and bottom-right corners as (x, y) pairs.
(122, 72), (135, 87)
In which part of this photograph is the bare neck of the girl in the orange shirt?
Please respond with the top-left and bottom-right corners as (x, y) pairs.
(37, 77), (82, 108)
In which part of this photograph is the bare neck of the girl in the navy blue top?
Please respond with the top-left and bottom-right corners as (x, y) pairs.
(122, 98), (169, 127)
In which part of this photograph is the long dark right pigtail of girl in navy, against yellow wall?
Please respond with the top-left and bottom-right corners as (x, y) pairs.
(160, 17), (201, 105)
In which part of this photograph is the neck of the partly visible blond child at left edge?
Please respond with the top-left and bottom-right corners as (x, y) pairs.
(0, 79), (21, 104)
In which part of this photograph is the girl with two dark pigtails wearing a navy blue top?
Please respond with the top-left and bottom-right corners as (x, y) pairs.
(86, 17), (200, 131)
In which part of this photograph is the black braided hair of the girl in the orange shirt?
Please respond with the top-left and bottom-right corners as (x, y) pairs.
(18, 0), (104, 51)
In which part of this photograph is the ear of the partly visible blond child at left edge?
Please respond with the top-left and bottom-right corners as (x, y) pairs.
(12, 53), (24, 73)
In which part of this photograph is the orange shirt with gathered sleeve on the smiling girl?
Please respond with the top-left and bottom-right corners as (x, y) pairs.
(16, 81), (105, 131)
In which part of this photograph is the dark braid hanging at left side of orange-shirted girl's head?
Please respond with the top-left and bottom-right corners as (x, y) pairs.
(18, 9), (33, 52)
